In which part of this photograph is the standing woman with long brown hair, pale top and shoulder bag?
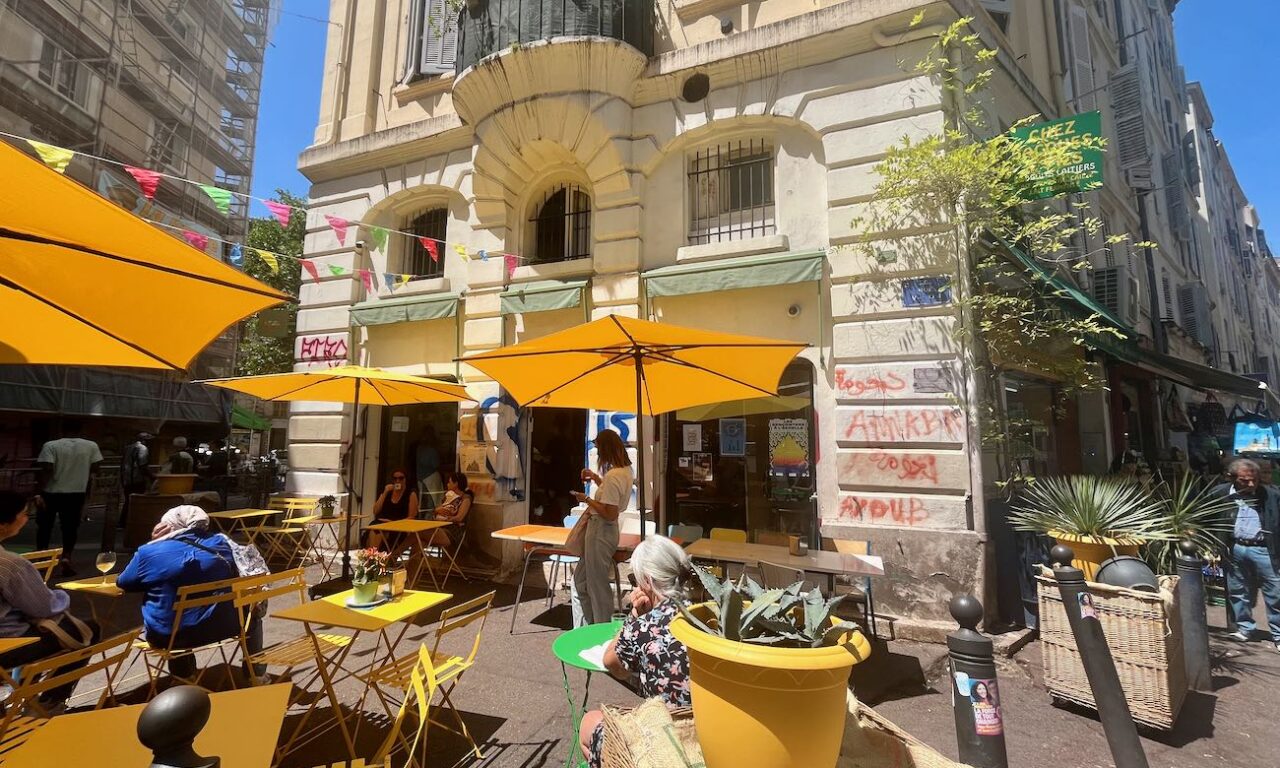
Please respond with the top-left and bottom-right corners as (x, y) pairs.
(573, 429), (634, 623)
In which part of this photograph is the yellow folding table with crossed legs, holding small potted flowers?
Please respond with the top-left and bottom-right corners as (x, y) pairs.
(271, 589), (453, 764)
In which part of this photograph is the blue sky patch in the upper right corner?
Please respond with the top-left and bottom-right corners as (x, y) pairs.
(1174, 0), (1280, 234)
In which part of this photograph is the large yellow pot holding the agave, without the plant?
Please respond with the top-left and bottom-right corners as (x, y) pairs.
(671, 605), (872, 768)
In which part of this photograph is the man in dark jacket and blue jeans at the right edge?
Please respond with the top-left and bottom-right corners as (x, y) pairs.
(1215, 458), (1280, 652)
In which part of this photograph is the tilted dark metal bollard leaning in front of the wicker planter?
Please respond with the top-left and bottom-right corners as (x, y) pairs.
(1050, 544), (1148, 768)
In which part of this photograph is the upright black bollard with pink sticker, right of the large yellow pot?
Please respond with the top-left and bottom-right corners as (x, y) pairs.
(947, 595), (1009, 768)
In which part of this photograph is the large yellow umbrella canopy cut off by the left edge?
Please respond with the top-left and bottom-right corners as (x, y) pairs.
(0, 142), (289, 370)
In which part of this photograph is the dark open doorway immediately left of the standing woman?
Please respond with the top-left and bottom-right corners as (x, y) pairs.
(529, 408), (586, 525)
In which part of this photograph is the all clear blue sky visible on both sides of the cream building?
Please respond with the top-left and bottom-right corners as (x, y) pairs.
(253, 0), (1280, 230)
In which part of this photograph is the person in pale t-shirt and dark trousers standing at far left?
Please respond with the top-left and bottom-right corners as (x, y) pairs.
(36, 420), (102, 576)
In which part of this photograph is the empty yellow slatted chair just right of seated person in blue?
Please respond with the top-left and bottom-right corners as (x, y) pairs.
(233, 568), (351, 685)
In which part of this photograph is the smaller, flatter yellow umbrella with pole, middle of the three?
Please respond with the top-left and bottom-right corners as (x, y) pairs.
(200, 365), (471, 579)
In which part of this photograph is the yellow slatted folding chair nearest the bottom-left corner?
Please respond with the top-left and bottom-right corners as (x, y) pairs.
(0, 630), (142, 763)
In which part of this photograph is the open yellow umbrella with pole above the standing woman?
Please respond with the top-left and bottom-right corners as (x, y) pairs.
(462, 315), (805, 536)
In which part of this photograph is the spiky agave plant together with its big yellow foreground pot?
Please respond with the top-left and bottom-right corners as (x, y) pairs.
(671, 568), (870, 768)
